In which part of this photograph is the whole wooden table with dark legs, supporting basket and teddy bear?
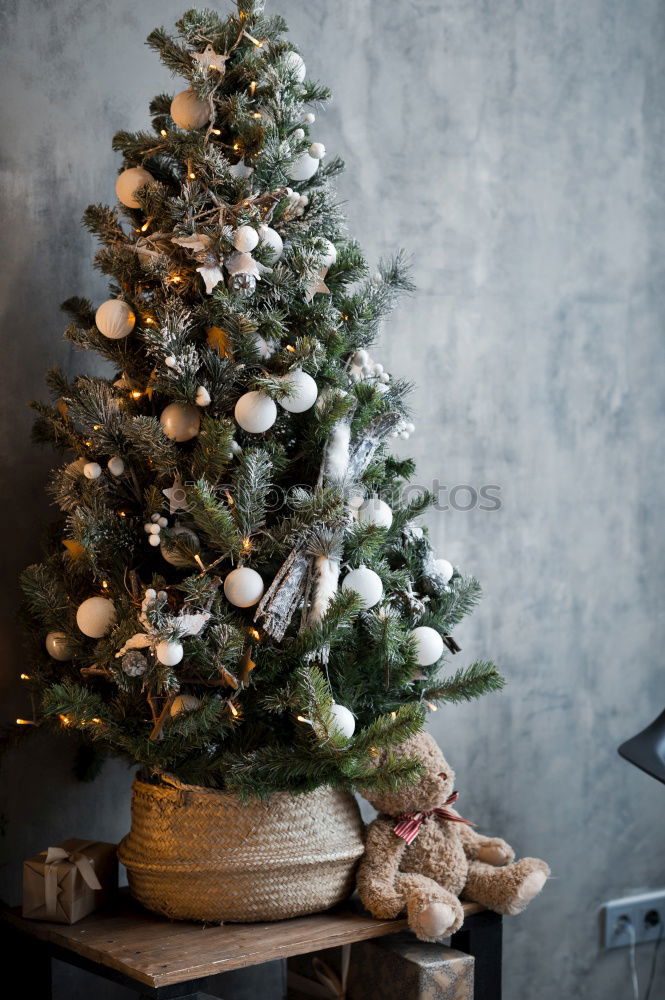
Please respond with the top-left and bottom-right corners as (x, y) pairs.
(0, 893), (501, 1000)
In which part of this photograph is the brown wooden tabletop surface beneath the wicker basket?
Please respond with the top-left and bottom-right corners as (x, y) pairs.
(2, 894), (482, 988)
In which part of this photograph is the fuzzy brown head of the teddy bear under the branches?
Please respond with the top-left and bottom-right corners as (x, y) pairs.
(361, 733), (455, 816)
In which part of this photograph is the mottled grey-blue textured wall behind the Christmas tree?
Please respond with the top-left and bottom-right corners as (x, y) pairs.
(0, 0), (665, 1000)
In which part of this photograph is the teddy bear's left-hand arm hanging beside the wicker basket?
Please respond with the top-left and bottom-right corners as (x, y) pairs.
(357, 817), (406, 920)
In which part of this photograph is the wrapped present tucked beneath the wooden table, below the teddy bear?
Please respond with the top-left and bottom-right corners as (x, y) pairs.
(288, 933), (473, 1000)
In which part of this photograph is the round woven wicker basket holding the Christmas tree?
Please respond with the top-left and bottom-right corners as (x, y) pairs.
(118, 776), (364, 923)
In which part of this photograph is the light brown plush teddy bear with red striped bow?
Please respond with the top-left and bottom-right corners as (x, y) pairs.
(357, 732), (550, 941)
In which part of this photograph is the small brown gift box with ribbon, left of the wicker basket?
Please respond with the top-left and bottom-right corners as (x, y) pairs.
(23, 839), (118, 924)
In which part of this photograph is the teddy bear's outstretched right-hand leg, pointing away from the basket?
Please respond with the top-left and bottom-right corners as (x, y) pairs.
(462, 858), (550, 914)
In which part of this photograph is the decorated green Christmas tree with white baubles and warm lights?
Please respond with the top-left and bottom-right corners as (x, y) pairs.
(22, 0), (502, 795)
